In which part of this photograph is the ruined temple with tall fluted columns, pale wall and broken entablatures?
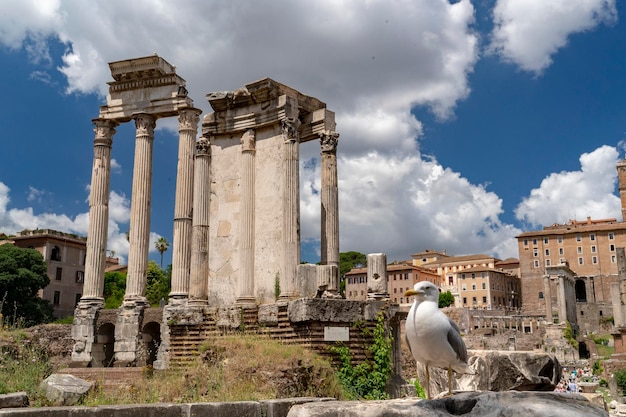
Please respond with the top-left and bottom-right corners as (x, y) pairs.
(72, 55), (400, 369)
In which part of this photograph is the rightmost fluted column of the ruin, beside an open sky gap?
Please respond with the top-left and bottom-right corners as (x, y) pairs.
(319, 132), (339, 267)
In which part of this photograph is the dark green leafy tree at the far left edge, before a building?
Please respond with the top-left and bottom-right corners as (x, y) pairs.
(0, 244), (54, 327)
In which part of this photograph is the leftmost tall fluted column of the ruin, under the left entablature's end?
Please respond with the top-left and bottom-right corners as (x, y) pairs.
(81, 119), (117, 302)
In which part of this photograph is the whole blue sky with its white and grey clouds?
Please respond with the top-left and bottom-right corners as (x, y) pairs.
(0, 0), (626, 263)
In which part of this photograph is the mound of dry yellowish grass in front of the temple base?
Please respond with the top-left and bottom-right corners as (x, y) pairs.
(83, 335), (344, 406)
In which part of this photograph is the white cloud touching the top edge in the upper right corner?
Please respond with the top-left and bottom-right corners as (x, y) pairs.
(489, 0), (617, 74)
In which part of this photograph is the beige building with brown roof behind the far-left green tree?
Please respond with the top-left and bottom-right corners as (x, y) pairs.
(12, 229), (86, 318)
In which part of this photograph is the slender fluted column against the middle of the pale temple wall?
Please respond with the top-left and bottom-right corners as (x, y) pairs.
(237, 129), (256, 305)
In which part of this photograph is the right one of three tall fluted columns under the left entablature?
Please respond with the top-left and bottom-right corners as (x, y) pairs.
(170, 108), (202, 299)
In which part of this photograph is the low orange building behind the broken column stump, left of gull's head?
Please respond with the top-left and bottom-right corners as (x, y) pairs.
(345, 263), (440, 304)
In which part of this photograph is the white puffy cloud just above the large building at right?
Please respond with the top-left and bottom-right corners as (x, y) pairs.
(515, 145), (622, 226)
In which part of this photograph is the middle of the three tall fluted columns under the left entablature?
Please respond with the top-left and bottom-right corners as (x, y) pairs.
(124, 113), (156, 303)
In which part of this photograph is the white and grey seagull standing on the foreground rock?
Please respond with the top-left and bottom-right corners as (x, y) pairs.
(404, 281), (474, 400)
